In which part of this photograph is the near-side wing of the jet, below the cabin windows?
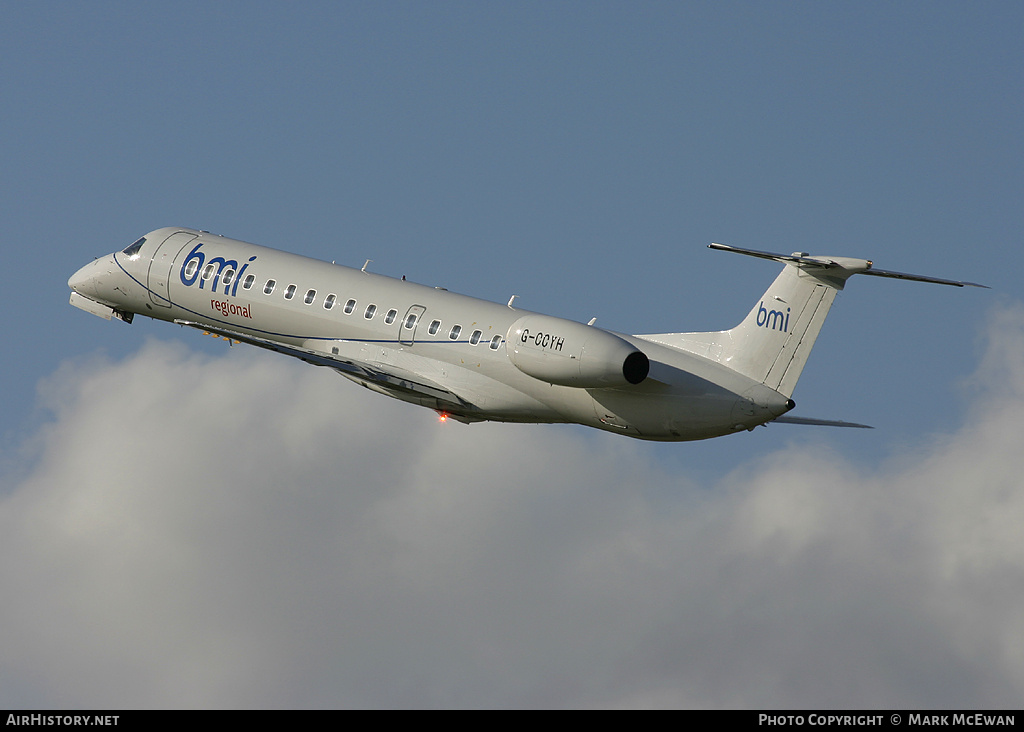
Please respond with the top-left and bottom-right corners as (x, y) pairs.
(174, 319), (477, 416)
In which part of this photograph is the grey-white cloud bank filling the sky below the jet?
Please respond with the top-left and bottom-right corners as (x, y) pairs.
(6, 308), (1024, 708)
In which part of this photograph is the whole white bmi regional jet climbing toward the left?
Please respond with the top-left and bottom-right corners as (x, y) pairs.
(68, 228), (983, 440)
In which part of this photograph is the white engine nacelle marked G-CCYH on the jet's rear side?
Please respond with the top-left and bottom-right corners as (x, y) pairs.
(505, 315), (650, 388)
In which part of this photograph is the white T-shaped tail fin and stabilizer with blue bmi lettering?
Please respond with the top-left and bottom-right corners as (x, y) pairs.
(642, 244), (985, 397)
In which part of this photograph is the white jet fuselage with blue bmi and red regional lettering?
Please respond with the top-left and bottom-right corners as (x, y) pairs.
(69, 228), (793, 440)
